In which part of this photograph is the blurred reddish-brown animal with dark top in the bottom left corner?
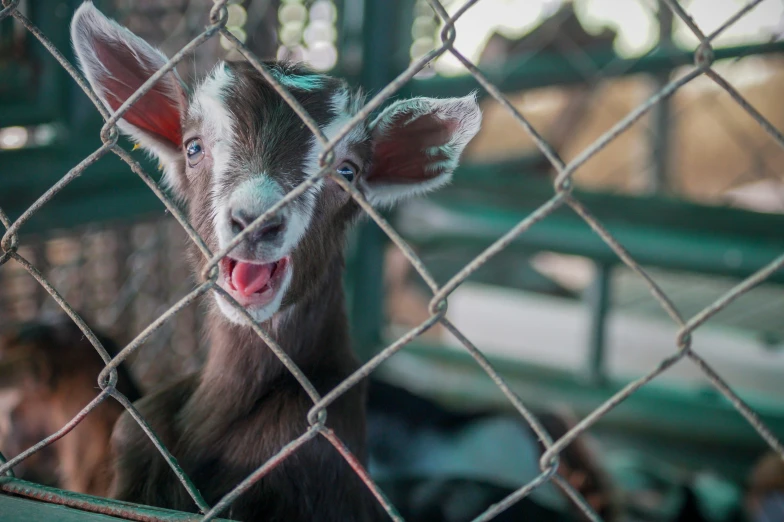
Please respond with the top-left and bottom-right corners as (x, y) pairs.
(0, 317), (141, 496)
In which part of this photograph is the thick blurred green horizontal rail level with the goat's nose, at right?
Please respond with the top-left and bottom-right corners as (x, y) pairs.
(404, 173), (784, 283)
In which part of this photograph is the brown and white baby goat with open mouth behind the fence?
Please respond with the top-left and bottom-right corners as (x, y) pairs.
(71, 3), (481, 522)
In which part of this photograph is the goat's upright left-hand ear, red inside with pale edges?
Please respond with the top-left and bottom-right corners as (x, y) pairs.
(71, 2), (186, 165)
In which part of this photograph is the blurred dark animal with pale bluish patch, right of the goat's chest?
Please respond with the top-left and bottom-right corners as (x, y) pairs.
(368, 378), (619, 522)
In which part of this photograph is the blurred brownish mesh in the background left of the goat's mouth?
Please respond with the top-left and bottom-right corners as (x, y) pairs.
(0, 219), (206, 389)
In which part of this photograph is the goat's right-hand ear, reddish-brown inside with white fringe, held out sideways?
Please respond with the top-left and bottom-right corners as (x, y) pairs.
(362, 94), (482, 206)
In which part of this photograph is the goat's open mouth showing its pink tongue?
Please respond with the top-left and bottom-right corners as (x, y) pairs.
(220, 257), (290, 307)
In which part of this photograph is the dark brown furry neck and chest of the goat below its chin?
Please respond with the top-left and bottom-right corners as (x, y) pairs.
(108, 250), (379, 521)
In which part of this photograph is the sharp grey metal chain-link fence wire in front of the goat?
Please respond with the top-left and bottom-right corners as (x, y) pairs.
(0, 0), (784, 521)
